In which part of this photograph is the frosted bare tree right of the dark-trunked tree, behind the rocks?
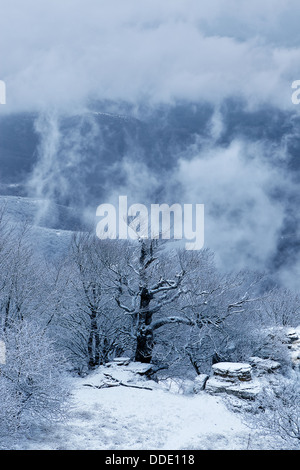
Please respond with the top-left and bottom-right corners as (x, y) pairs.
(170, 250), (264, 373)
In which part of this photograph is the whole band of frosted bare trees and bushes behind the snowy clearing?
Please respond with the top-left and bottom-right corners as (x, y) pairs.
(0, 207), (300, 448)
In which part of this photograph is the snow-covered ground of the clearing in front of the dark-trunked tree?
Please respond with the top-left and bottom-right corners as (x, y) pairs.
(9, 366), (284, 450)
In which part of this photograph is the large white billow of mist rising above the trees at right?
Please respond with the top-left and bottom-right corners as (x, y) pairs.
(174, 134), (287, 270)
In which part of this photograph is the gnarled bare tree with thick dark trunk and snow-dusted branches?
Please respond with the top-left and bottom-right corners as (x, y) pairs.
(103, 239), (197, 363)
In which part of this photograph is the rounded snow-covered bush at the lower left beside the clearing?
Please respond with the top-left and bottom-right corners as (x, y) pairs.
(0, 321), (68, 439)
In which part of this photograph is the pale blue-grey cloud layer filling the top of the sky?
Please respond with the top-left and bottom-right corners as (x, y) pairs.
(0, 0), (300, 111)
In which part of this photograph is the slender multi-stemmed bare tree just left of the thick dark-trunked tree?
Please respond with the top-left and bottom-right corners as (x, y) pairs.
(59, 233), (128, 369)
